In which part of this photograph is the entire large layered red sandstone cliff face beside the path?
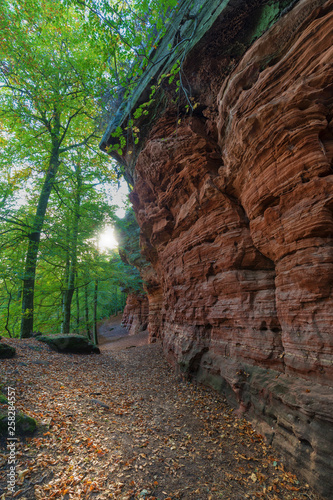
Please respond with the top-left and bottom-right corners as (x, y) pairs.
(102, 0), (333, 498)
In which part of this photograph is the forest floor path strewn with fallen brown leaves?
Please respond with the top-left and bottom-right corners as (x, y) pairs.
(0, 321), (319, 500)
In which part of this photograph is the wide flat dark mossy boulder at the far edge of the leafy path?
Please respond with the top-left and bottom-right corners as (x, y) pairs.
(36, 334), (100, 354)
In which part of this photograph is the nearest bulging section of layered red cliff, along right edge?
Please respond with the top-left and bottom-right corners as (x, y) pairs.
(217, 2), (333, 383)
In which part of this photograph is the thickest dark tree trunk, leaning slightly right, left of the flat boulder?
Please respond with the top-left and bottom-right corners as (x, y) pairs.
(20, 144), (60, 338)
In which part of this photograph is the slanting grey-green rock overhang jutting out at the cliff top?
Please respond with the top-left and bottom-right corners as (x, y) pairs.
(100, 0), (296, 184)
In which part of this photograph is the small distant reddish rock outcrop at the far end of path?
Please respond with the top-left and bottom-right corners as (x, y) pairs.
(121, 293), (149, 335)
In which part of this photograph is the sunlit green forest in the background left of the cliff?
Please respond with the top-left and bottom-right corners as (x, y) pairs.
(0, 0), (177, 338)
